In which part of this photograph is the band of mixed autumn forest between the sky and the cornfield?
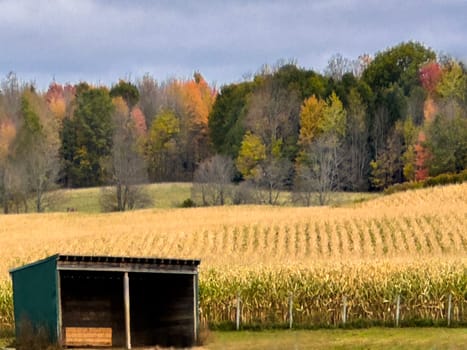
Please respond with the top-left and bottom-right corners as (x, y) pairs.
(0, 42), (467, 214)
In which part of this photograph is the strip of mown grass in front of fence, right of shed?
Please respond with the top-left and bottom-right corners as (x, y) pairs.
(206, 328), (467, 350)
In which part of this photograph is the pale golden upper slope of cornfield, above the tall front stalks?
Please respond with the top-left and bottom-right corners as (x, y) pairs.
(0, 184), (467, 277)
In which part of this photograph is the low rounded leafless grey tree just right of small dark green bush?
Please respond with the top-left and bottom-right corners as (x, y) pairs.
(191, 155), (235, 206)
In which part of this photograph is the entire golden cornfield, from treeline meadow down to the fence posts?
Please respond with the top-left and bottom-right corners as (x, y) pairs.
(0, 184), (467, 327)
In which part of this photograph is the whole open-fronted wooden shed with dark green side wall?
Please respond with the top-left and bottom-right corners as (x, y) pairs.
(10, 255), (200, 349)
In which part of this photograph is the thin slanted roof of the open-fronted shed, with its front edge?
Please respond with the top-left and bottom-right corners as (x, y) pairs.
(10, 254), (200, 274)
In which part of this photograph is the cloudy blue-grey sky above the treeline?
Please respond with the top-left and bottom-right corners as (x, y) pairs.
(0, 0), (467, 89)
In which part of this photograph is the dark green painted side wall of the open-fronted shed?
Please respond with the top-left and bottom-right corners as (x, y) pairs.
(11, 256), (58, 342)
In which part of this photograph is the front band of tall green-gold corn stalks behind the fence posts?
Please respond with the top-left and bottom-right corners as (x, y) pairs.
(200, 263), (467, 327)
